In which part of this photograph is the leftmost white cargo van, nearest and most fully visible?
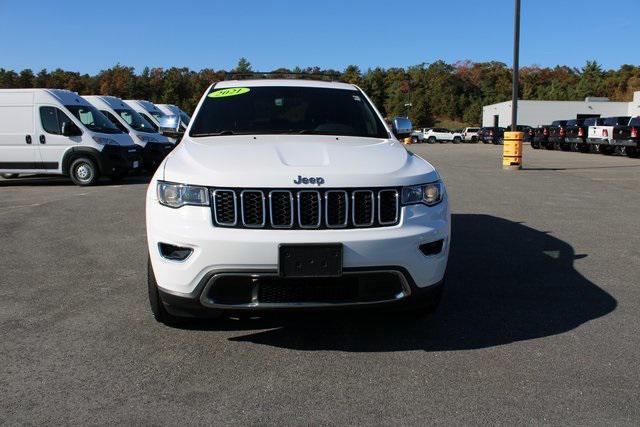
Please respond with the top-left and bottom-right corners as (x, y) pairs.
(0, 89), (142, 185)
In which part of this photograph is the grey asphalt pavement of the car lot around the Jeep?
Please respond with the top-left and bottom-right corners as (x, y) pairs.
(0, 144), (640, 425)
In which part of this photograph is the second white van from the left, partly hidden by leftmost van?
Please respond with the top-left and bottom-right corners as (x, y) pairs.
(83, 95), (174, 172)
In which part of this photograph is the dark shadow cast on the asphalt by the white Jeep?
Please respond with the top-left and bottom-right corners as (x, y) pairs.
(201, 214), (617, 352)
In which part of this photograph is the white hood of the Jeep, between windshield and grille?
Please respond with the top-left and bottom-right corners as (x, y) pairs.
(164, 135), (439, 188)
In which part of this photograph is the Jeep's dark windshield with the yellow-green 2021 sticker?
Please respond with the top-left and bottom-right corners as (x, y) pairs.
(191, 86), (389, 138)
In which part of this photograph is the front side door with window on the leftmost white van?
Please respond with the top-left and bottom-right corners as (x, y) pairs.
(34, 105), (82, 173)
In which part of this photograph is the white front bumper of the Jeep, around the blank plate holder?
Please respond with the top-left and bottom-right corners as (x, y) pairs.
(147, 191), (451, 309)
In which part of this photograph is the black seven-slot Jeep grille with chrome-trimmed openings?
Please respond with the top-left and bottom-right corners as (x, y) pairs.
(211, 188), (400, 230)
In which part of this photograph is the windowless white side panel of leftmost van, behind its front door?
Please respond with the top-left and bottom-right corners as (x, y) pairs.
(0, 93), (40, 173)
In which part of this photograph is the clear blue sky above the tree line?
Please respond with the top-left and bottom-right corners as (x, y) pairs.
(0, 0), (640, 74)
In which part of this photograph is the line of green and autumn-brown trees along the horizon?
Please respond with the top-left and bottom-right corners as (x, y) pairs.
(0, 58), (640, 127)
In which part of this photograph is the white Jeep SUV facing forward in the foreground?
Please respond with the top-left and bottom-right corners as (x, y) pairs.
(146, 79), (451, 323)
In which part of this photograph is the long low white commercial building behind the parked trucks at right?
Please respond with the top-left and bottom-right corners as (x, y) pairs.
(482, 91), (640, 127)
